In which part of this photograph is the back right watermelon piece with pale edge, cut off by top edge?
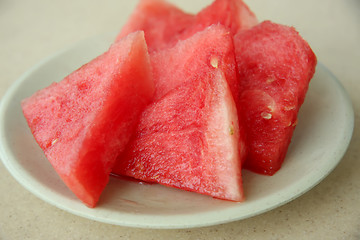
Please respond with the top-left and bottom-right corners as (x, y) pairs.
(181, 0), (258, 39)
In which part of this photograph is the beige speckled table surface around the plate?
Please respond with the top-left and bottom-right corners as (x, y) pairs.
(0, 0), (360, 240)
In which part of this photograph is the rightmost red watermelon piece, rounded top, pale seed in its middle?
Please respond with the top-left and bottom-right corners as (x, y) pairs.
(234, 21), (317, 175)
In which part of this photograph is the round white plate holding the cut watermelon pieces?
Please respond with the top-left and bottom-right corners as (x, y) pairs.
(0, 35), (354, 228)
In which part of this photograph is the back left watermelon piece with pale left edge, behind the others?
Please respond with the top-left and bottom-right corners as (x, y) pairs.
(116, 0), (195, 52)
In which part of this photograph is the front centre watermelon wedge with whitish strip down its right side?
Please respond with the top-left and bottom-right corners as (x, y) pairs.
(113, 69), (243, 201)
